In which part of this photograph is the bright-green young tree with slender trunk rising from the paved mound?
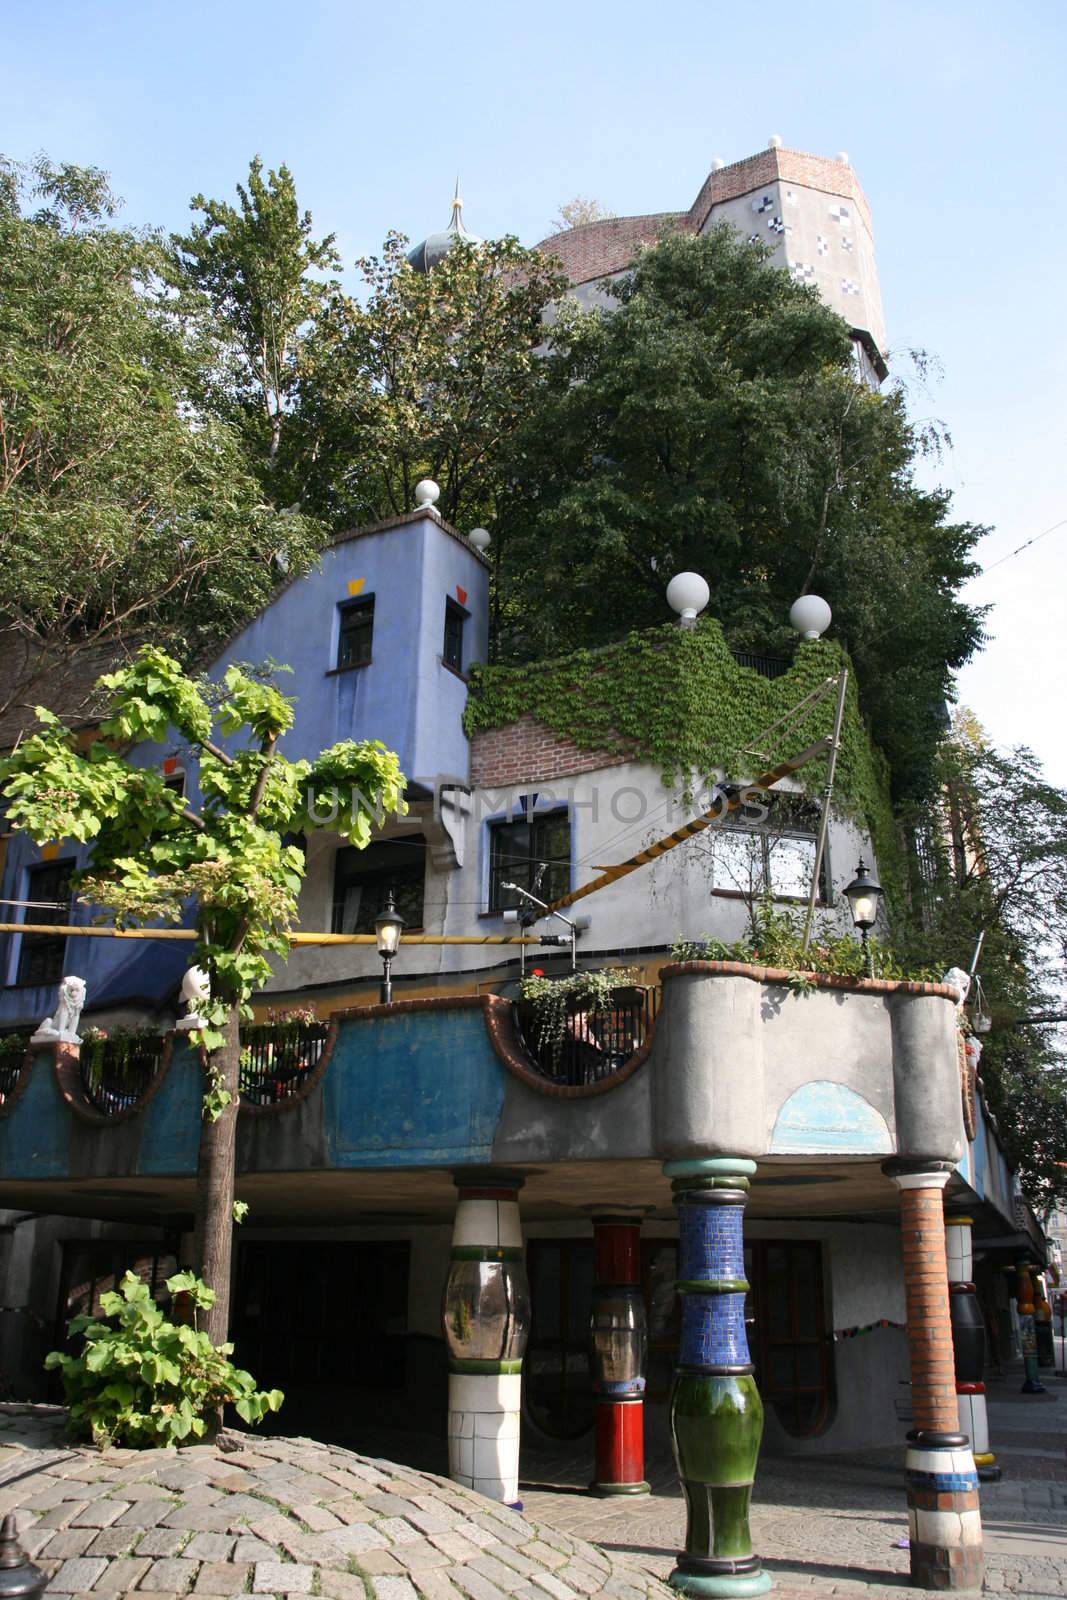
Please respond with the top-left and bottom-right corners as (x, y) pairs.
(0, 648), (405, 1346)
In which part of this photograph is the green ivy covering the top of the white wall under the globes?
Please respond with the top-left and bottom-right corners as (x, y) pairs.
(464, 618), (902, 899)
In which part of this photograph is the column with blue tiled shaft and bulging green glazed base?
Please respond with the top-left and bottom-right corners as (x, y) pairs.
(664, 1157), (771, 1597)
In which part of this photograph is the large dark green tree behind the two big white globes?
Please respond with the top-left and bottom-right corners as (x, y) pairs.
(499, 226), (982, 795)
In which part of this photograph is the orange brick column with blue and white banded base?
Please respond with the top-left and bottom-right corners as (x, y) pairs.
(886, 1162), (984, 1589)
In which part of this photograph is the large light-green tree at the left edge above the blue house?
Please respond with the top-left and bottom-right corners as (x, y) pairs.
(0, 158), (318, 729)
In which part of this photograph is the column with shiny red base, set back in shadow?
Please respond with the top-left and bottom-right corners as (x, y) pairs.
(589, 1213), (648, 1494)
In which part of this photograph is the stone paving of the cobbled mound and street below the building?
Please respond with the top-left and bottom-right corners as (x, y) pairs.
(0, 1374), (1067, 1600)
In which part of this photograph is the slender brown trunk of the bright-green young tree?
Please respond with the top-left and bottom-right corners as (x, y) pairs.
(197, 1005), (242, 1344)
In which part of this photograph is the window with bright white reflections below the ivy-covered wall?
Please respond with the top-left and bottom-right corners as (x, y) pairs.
(712, 792), (830, 901)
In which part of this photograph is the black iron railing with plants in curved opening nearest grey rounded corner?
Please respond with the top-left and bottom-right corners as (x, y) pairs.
(515, 987), (659, 1088)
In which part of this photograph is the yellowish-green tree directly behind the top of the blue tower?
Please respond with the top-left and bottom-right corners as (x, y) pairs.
(289, 234), (569, 531)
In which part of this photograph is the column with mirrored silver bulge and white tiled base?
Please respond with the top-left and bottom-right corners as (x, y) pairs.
(443, 1171), (530, 1507)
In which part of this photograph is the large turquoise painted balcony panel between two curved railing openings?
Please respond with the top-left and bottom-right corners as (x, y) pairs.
(323, 1008), (504, 1166)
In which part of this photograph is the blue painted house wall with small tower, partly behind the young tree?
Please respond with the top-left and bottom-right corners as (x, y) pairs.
(0, 514), (490, 1030)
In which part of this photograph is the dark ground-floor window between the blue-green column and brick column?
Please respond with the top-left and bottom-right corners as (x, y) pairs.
(745, 1238), (833, 1438)
